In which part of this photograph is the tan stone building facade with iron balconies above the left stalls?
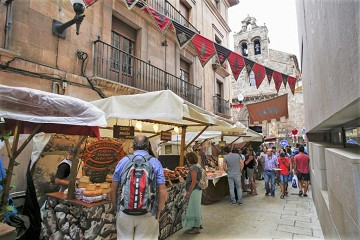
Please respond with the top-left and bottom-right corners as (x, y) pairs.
(0, 0), (239, 118)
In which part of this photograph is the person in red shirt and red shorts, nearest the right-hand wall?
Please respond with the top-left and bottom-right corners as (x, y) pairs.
(294, 146), (310, 197)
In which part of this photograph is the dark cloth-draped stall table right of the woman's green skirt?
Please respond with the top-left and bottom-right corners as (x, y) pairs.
(201, 172), (229, 205)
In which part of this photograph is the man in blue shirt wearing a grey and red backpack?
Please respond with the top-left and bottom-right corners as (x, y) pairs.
(110, 136), (166, 240)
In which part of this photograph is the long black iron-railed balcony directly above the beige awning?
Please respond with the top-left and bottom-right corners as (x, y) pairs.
(94, 40), (202, 106)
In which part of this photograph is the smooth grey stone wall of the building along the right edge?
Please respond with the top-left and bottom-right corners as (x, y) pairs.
(296, 1), (360, 239)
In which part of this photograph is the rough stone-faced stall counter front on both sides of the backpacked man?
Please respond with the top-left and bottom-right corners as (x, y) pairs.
(40, 183), (187, 240)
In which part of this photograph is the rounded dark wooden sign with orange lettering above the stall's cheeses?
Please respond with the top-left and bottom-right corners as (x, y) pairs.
(81, 140), (126, 183)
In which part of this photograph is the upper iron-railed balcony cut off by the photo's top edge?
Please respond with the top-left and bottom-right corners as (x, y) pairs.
(146, 0), (200, 33)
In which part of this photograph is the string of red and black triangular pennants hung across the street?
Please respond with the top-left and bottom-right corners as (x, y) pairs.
(126, 0), (296, 95)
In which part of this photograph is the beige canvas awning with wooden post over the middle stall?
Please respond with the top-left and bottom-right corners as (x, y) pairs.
(91, 90), (242, 164)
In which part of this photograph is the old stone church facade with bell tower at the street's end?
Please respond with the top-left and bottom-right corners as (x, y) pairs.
(232, 16), (304, 137)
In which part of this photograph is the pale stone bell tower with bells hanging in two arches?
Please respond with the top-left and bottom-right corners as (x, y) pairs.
(234, 16), (270, 59)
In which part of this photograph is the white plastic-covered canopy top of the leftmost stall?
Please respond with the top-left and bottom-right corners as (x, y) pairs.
(0, 85), (106, 126)
